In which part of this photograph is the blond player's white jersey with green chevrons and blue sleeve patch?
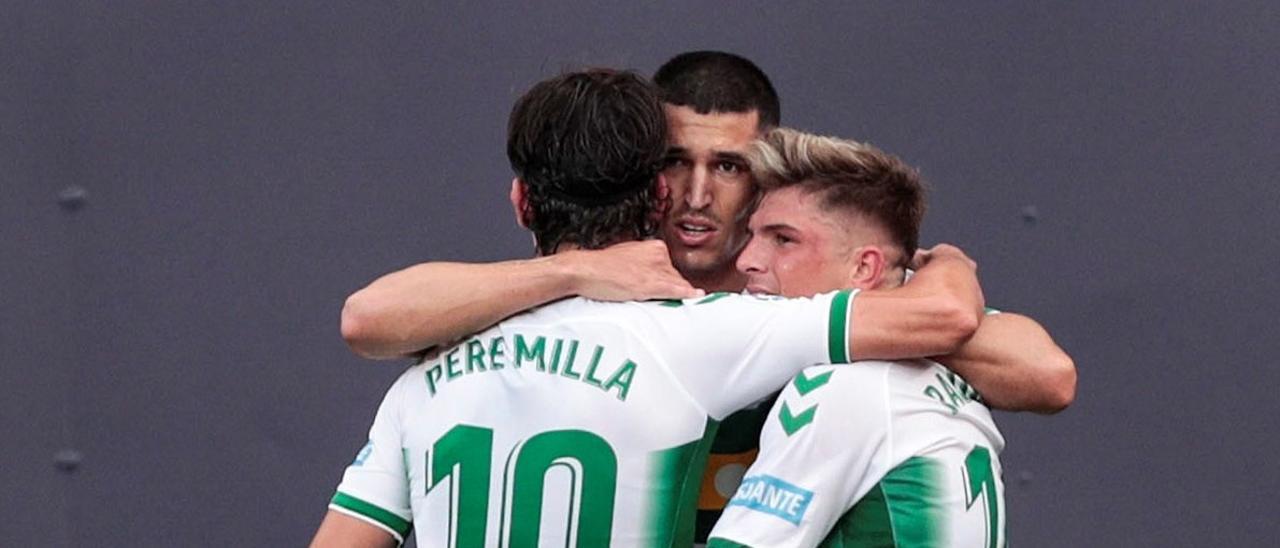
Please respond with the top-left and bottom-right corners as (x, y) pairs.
(708, 360), (1005, 548)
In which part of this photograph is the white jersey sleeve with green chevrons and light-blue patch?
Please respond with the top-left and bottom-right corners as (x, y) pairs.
(708, 362), (892, 548)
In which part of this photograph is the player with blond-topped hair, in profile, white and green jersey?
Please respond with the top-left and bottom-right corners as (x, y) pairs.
(709, 129), (1024, 548)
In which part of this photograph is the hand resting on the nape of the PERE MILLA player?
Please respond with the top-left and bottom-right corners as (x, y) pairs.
(561, 239), (704, 301)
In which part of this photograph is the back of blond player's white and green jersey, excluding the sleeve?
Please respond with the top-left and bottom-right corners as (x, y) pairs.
(849, 360), (1006, 548)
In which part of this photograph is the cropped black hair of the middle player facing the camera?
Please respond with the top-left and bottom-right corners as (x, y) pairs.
(653, 51), (782, 129)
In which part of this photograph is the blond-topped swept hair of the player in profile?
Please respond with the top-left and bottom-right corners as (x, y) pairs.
(750, 128), (924, 268)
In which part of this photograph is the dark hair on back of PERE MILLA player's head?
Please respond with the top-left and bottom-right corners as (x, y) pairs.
(507, 69), (667, 255)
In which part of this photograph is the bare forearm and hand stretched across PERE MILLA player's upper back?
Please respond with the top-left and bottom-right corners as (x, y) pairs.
(342, 241), (699, 359)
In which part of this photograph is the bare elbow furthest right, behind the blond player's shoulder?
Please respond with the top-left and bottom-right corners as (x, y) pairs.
(936, 309), (1075, 414)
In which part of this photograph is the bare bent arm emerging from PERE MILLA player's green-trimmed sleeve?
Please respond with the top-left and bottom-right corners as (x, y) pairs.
(849, 245), (984, 360)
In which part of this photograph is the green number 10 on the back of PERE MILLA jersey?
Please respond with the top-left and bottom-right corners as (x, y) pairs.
(426, 424), (618, 548)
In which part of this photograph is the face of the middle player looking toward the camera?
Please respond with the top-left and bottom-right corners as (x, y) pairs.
(662, 105), (759, 278)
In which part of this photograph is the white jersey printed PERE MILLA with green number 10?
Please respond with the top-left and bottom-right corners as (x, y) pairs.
(330, 291), (856, 548)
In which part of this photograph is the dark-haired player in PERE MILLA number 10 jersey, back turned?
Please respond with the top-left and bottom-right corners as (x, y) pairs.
(314, 69), (982, 547)
